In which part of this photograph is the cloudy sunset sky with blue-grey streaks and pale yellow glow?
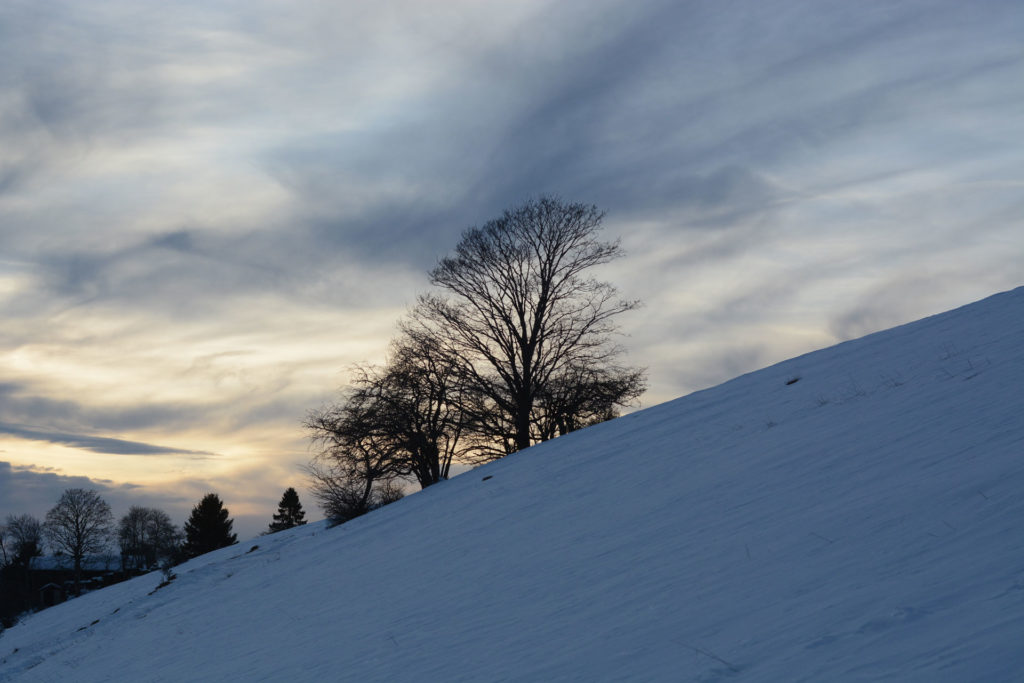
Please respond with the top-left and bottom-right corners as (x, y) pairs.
(0, 0), (1024, 538)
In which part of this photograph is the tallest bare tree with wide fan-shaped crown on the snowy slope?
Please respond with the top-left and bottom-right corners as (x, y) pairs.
(406, 197), (644, 458)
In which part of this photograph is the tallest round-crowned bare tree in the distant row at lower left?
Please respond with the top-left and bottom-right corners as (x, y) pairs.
(43, 488), (113, 594)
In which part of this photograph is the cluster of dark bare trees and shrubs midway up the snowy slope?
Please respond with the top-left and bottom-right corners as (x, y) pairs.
(305, 197), (645, 521)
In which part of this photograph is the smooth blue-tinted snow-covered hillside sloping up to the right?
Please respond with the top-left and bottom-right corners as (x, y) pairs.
(0, 288), (1024, 681)
